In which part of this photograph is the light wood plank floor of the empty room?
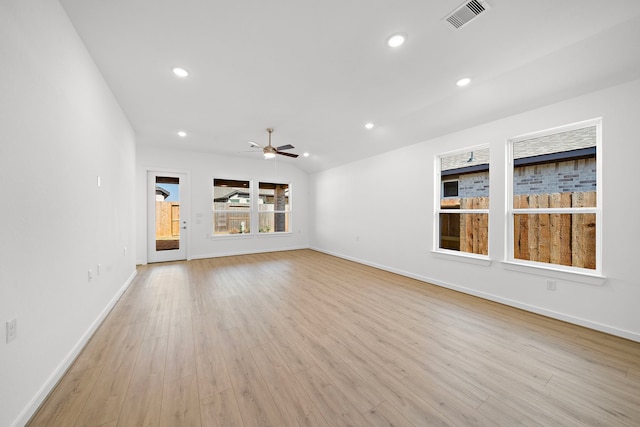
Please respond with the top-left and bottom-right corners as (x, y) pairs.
(30, 250), (640, 427)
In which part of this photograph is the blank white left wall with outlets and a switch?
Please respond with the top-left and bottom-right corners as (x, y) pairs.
(0, 0), (135, 426)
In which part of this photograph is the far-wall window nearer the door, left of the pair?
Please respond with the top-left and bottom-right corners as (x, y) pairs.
(213, 178), (251, 235)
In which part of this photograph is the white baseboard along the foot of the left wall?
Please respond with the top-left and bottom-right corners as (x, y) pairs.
(12, 270), (138, 427)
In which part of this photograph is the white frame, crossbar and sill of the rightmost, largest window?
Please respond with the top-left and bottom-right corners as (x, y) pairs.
(503, 117), (606, 285)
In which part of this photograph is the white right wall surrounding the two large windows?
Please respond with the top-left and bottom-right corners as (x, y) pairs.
(310, 81), (640, 341)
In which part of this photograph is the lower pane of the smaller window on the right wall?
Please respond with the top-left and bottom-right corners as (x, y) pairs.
(440, 212), (489, 255)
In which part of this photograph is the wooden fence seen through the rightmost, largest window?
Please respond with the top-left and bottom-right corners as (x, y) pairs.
(513, 192), (596, 269)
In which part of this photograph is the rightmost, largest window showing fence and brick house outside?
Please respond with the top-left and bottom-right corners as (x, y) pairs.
(508, 119), (601, 272)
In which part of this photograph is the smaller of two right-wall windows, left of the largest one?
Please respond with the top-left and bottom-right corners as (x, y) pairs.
(436, 147), (489, 255)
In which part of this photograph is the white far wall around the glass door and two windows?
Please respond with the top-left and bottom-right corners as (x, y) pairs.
(136, 146), (309, 264)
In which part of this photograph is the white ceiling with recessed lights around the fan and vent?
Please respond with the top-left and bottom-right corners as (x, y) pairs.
(61, 0), (640, 172)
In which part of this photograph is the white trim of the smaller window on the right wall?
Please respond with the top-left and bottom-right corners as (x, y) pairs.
(431, 144), (491, 265)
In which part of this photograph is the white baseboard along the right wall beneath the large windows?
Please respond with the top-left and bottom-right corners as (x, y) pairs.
(310, 247), (640, 342)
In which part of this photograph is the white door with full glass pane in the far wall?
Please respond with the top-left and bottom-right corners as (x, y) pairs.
(147, 171), (189, 262)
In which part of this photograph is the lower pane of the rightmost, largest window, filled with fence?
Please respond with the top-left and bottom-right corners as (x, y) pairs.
(514, 214), (596, 269)
